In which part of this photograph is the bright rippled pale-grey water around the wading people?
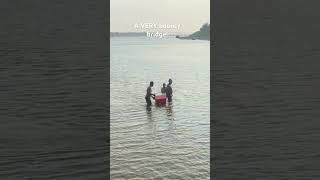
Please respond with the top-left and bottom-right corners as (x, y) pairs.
(110, 37), (210, 179)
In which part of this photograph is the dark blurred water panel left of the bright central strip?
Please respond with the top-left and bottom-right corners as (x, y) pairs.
(0, 0), (109, 180)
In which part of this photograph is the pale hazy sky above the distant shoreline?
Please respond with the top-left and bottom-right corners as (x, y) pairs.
(110, 0), (210, 32)
